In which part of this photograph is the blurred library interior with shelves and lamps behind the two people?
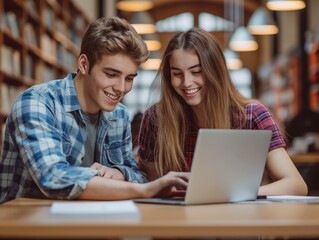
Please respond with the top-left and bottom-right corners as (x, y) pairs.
(0, 0), (319, 195)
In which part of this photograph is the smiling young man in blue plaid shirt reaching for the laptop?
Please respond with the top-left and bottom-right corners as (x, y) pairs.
(0, 17), (188, 203)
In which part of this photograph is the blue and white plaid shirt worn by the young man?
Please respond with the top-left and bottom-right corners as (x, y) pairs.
(0, 73), (146, 203)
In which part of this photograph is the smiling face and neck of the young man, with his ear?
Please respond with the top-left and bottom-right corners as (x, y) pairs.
(77, 53), (138, 113)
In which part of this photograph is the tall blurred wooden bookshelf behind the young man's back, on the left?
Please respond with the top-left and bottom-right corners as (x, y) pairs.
(0, 0), (89, 152)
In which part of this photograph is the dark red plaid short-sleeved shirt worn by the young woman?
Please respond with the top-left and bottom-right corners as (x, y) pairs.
(138, 102), (286, 169)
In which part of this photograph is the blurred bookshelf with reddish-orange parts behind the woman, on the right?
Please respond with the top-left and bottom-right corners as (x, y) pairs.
(260, 46), (319, 124)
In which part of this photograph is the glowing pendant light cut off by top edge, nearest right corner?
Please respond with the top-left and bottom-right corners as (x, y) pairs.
(266, 0), (306, 11)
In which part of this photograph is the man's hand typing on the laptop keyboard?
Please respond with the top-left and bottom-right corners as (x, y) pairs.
(144, 172), (190, 198)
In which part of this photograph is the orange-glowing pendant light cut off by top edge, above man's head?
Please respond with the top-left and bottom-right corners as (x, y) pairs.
(116, 0), (154, 12)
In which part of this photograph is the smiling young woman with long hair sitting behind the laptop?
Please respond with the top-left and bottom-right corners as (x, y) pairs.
(139, 28), (307, 195)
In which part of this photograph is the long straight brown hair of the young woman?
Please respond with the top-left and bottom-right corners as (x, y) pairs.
(154, 28), (250, 176)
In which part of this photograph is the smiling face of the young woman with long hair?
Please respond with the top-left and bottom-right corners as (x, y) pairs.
(169, 49), (205, 108)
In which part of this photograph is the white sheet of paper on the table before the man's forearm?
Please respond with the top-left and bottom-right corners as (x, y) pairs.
(50, 200), (139, 217)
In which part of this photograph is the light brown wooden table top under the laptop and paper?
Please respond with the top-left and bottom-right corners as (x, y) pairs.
(0, 199), (319, 239)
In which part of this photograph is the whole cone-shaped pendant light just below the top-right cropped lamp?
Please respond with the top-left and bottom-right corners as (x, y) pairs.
(247, 7), (278, 35)
